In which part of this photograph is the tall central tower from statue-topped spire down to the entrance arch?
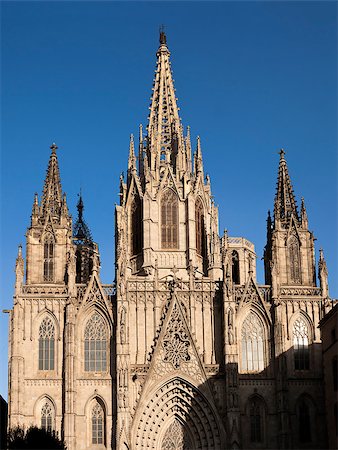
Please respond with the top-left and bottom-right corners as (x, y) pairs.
(116, 32), (225, 449)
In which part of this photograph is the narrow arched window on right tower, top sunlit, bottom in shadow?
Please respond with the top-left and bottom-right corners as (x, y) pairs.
(293, 318), (310, 370)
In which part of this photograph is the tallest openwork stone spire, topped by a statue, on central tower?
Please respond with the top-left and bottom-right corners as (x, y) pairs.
(147, 31), (186, 178)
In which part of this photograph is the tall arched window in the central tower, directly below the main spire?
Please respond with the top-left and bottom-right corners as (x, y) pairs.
(161, 189), (178, 249)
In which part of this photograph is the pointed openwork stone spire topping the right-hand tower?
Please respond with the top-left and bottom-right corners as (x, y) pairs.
(274, 149), (299, 225)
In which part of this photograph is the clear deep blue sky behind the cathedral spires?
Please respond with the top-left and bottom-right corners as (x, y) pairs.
(0, 1), (338, 397)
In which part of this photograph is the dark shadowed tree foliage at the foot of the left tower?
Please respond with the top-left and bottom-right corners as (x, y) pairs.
(7, 426), (67, 450)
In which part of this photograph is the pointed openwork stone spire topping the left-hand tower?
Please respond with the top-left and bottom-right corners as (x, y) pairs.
(40, 143), (62, 219)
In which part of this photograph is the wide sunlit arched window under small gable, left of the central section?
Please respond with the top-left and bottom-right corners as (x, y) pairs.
(84, 312), (107, 372)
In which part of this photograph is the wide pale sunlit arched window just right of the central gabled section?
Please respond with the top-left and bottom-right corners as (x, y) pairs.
(241, 312), (264, 372)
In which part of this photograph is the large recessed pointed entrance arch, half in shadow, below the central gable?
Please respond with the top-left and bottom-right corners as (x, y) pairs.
(132, 377), (225, 450)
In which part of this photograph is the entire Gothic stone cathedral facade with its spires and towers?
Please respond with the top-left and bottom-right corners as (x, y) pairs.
(9, 32), (329, 450)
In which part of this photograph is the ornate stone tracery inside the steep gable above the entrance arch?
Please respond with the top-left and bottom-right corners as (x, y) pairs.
(163, 304), (190, 369)
